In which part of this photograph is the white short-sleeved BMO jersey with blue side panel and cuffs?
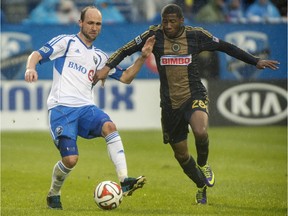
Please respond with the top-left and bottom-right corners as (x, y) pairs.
(38, 35), (118, 109)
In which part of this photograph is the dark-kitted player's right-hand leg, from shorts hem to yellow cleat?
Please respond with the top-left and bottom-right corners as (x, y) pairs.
(189, 110), (215, 187)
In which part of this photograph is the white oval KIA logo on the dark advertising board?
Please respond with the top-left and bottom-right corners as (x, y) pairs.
(217, 83), (288, 125)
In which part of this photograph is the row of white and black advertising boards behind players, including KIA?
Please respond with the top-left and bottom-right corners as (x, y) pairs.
(0, 79), (287, 130)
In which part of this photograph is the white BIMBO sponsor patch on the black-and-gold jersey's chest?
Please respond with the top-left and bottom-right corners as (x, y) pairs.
(160, 55), (192, 66)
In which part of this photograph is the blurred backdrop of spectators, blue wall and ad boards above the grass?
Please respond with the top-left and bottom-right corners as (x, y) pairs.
(0, 0), (287, 130)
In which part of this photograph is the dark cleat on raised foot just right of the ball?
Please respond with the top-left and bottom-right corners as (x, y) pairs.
(120, 176), (146, 196)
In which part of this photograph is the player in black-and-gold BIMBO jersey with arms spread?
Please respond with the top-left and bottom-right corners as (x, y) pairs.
(93, 4), (279, 204)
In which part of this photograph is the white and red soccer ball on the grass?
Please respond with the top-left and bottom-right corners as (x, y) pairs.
(94, 181), (123, 210)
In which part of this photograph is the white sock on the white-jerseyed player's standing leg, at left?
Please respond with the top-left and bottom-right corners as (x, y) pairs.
(48, 161), (72, 196)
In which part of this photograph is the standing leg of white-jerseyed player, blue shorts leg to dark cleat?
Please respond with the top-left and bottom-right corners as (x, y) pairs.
(47, 107), (78, 209)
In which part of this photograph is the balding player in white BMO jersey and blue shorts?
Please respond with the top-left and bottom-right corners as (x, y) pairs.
(25, 6), (155, 209)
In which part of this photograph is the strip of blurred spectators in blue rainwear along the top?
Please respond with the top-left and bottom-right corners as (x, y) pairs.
(1, 0), (287, 24)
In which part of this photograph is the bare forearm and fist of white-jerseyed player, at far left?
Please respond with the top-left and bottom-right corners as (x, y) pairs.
(25, 51), (42, 82)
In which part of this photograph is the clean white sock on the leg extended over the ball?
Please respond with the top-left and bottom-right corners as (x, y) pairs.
(105, 131), (128, 182)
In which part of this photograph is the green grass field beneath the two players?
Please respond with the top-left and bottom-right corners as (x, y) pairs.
(1, 127), (287, 216)
